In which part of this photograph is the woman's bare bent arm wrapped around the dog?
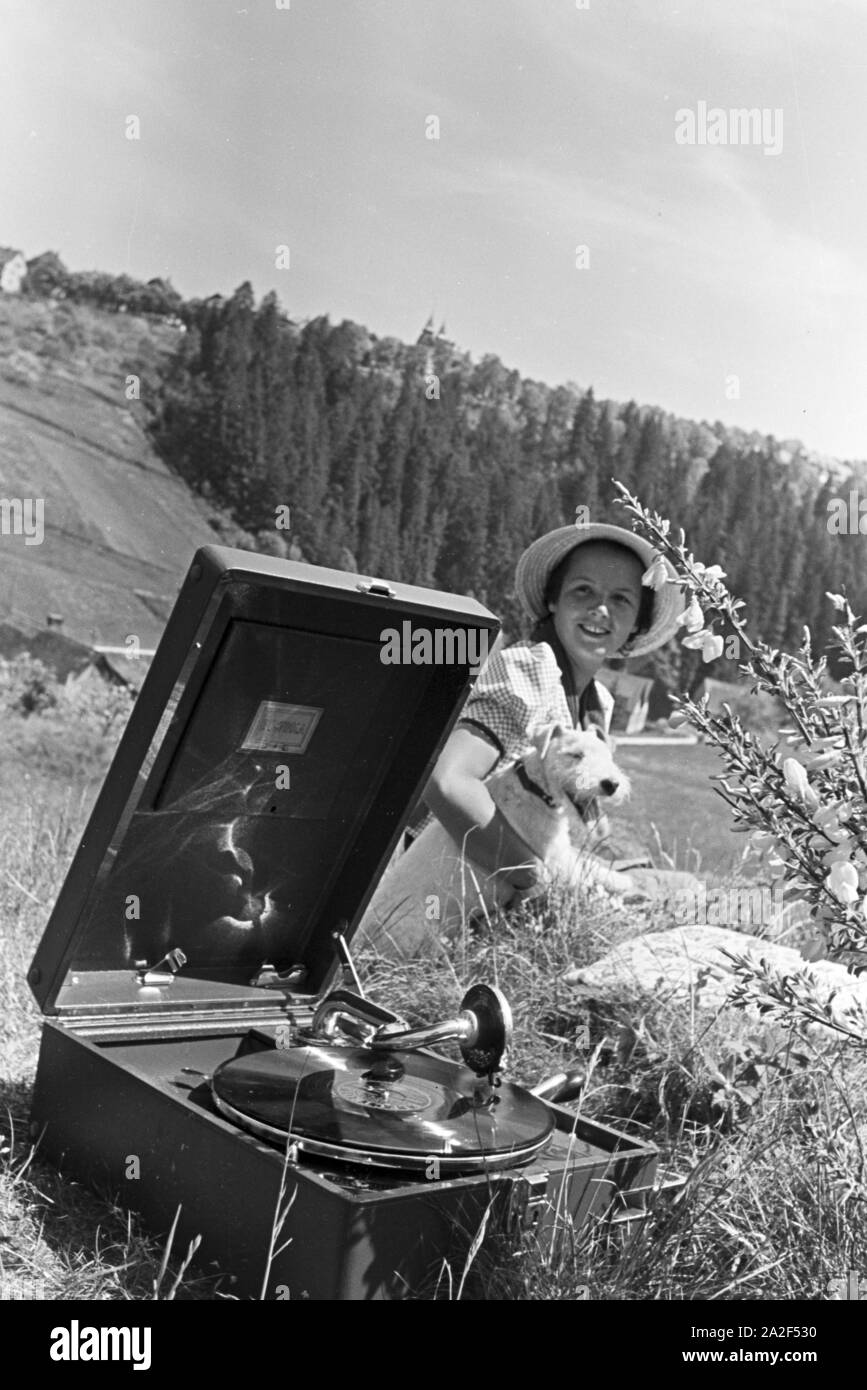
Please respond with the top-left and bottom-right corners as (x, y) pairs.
(424, 728), (538, 888)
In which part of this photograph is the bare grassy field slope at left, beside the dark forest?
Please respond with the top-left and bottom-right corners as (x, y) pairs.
(0, 296), (215, 648)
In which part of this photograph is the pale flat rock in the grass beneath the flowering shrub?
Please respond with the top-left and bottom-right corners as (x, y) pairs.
(563, 927), (867, 1024)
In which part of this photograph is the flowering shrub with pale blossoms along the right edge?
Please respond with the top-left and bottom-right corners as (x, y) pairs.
(616, 484), (867, 1047)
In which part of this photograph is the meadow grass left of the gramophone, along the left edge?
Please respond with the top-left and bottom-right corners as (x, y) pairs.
(0, 696), (230, 1300)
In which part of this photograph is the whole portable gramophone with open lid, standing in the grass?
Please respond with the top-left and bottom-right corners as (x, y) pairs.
(29, 548), (656, 1300)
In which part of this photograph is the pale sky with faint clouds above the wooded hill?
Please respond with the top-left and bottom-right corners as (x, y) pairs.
(0, 0), (867, 459)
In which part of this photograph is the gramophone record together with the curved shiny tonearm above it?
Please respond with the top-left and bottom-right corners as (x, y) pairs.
(211, 984), (554, 1176)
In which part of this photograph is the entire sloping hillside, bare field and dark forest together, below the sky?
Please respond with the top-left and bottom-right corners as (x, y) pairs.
(0, 261), (867, 689)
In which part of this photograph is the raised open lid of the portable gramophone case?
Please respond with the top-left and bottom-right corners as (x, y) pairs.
(29, 546), (499, 1015)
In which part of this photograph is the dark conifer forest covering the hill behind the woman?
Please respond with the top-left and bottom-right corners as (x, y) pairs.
(28, 253), (867, 688)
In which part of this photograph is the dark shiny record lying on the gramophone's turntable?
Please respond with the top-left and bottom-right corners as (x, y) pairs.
(211, 1044), (554, 1172)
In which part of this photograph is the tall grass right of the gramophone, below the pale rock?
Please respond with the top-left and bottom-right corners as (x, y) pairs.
(363, 884), (867, 1300)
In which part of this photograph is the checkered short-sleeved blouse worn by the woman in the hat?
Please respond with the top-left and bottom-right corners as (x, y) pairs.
(407, 641), (614, 837)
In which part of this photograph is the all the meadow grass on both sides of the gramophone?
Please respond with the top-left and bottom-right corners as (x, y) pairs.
(0, 703), (867, 1301)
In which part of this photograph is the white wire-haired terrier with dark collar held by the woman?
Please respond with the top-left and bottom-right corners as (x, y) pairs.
(360, 724), (632, 958)
